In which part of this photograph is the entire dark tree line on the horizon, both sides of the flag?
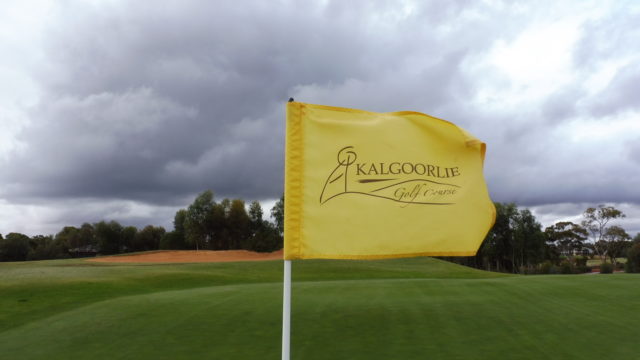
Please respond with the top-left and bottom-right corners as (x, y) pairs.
(0, 194), (640, 273)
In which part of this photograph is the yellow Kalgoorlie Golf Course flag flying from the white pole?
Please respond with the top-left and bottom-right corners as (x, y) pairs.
(284, 102), (495, 260)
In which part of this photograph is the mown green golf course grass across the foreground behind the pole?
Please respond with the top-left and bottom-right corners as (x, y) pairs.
(0, 258), (640, 359)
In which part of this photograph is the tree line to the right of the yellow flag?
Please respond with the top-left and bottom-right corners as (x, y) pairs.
(446, 203), (640, 273)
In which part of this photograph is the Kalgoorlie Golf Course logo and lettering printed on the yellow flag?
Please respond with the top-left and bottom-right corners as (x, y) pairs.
(320, 146), (462, 207)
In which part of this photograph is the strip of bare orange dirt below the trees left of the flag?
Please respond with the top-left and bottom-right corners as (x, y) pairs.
(87, 250), (282, 263)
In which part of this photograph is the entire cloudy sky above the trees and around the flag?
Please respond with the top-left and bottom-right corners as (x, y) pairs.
(0, 0), (640, 236)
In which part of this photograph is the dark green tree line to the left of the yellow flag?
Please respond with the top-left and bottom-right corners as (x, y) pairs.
(0, 190), (284, 261)
